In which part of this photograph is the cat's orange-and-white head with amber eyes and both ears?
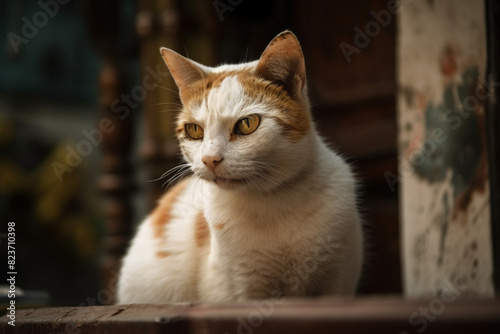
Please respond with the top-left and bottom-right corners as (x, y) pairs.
(160, 31), (313, 191)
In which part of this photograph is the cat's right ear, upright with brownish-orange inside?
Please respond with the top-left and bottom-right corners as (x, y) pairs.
(256, 31), (306, 99)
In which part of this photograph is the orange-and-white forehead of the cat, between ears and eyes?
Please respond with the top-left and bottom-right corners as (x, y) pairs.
(177, 68), (311, 141)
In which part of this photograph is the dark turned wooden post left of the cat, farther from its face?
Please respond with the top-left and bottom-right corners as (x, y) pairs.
(84, 0), (134, 304)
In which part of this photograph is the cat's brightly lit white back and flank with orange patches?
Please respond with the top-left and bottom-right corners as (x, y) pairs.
(118, 179), (209, 304)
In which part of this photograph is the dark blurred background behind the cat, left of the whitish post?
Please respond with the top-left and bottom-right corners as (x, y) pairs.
(0, 0), (496, 305)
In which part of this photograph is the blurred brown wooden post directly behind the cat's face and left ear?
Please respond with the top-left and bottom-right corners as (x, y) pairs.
(136, 0), (180, 211)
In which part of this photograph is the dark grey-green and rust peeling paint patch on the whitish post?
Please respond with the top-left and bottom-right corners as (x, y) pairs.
(411, 64), (487, 216)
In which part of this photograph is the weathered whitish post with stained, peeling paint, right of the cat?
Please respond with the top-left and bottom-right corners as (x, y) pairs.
(397, 0), (494, 296)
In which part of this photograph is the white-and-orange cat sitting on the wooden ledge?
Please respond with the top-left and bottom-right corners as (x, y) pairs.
(117, 31), (363, 304)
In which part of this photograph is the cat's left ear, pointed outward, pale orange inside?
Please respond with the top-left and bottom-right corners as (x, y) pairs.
(160, 48), (205, 101)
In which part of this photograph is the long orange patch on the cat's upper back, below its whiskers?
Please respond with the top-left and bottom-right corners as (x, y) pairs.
(151, 179), (189, 239)
